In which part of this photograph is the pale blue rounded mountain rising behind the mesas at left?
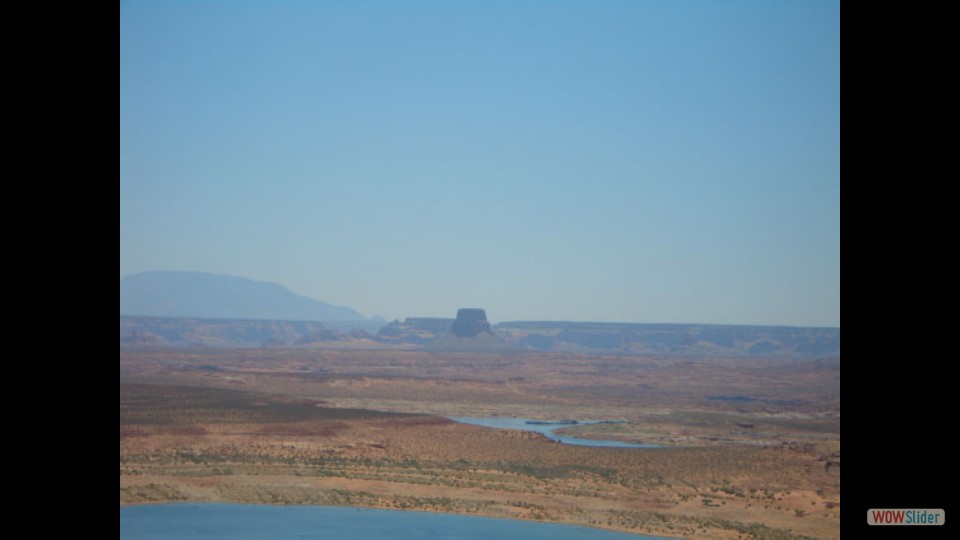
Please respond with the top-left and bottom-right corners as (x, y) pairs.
(120, 272), (365, 321)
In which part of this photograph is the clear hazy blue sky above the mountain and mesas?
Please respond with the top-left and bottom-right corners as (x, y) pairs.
(120, 0), (840, 326)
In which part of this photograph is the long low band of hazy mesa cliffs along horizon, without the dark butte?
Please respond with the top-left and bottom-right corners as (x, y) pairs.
(120, 316), (840, 358)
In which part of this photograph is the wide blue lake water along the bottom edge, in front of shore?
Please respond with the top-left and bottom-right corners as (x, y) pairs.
(120, 503), (672, 540)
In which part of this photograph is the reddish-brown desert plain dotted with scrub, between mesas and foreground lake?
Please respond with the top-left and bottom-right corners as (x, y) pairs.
(120, 349), (839, 538)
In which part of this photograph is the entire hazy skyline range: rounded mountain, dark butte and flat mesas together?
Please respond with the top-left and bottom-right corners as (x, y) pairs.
(120, 272), (840, 358)
